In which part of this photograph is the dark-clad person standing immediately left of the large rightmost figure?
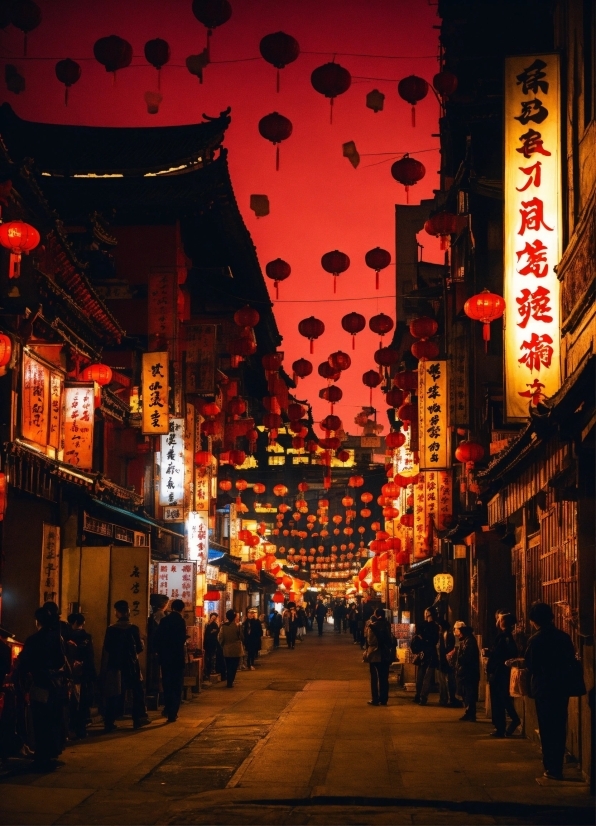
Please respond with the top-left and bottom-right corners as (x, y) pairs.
(483, 613), (521, 737)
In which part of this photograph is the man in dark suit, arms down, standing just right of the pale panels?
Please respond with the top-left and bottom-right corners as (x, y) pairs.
(155, 599), (187, 723)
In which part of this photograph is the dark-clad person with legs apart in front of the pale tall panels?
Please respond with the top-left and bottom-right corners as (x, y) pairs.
(101, 599), (150, 732)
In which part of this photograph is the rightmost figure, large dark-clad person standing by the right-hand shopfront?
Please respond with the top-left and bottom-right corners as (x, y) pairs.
(526, 602), (575, 780)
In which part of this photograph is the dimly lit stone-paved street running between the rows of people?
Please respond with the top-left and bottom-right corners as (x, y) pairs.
(0, 629), (594, 826)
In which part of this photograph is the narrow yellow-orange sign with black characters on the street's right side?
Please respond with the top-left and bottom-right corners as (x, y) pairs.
(418, 361), (450, 470)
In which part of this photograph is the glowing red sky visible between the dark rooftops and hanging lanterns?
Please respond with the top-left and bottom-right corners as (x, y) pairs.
(0, 0), (439, 433)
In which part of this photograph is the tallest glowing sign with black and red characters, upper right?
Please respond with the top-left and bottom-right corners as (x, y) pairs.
(504, 54), (561, 421)
